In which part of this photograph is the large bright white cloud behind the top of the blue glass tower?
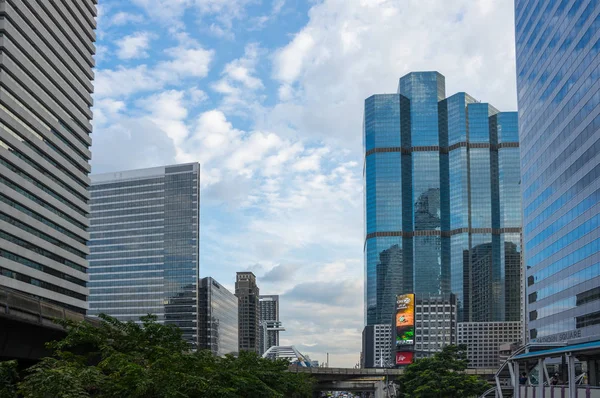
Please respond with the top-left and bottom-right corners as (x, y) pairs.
(270, 0), (516, 153)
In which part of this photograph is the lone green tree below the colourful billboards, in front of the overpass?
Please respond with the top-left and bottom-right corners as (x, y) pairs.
(399, 345), (489, 398)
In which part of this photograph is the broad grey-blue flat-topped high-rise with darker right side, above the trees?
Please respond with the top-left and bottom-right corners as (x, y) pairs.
(89, 163), (200, 348)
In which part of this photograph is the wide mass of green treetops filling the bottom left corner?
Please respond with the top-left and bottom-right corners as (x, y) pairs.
(0, 315), (312, 398)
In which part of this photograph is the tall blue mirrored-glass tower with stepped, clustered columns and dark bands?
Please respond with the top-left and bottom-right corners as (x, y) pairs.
(364, 72), (521, 325)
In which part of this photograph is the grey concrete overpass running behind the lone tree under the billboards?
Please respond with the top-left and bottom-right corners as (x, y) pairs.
(289, 366), (497, 398)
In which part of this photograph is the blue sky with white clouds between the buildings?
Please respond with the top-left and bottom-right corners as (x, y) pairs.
(92, 0), (516, 367)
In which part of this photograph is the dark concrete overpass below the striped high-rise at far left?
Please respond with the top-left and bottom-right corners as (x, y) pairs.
(0, 286), (90, 365)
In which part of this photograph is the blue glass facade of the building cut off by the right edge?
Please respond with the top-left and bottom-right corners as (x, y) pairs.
(515, 0), (600, 342)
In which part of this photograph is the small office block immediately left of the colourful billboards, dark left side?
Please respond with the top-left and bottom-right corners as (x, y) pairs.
(361, 323), (393, 368)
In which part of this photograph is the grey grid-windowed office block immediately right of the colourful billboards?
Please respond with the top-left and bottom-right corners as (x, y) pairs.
(414, 294), (458, 359)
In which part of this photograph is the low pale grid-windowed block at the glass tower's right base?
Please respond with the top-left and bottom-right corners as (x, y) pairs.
(458, 321), (522, 369)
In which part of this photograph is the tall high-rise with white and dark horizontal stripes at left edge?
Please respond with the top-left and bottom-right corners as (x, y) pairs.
(0, 0), (96, 314)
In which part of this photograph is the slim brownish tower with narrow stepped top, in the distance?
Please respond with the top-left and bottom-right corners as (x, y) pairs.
(235, 272), (260, 353)
